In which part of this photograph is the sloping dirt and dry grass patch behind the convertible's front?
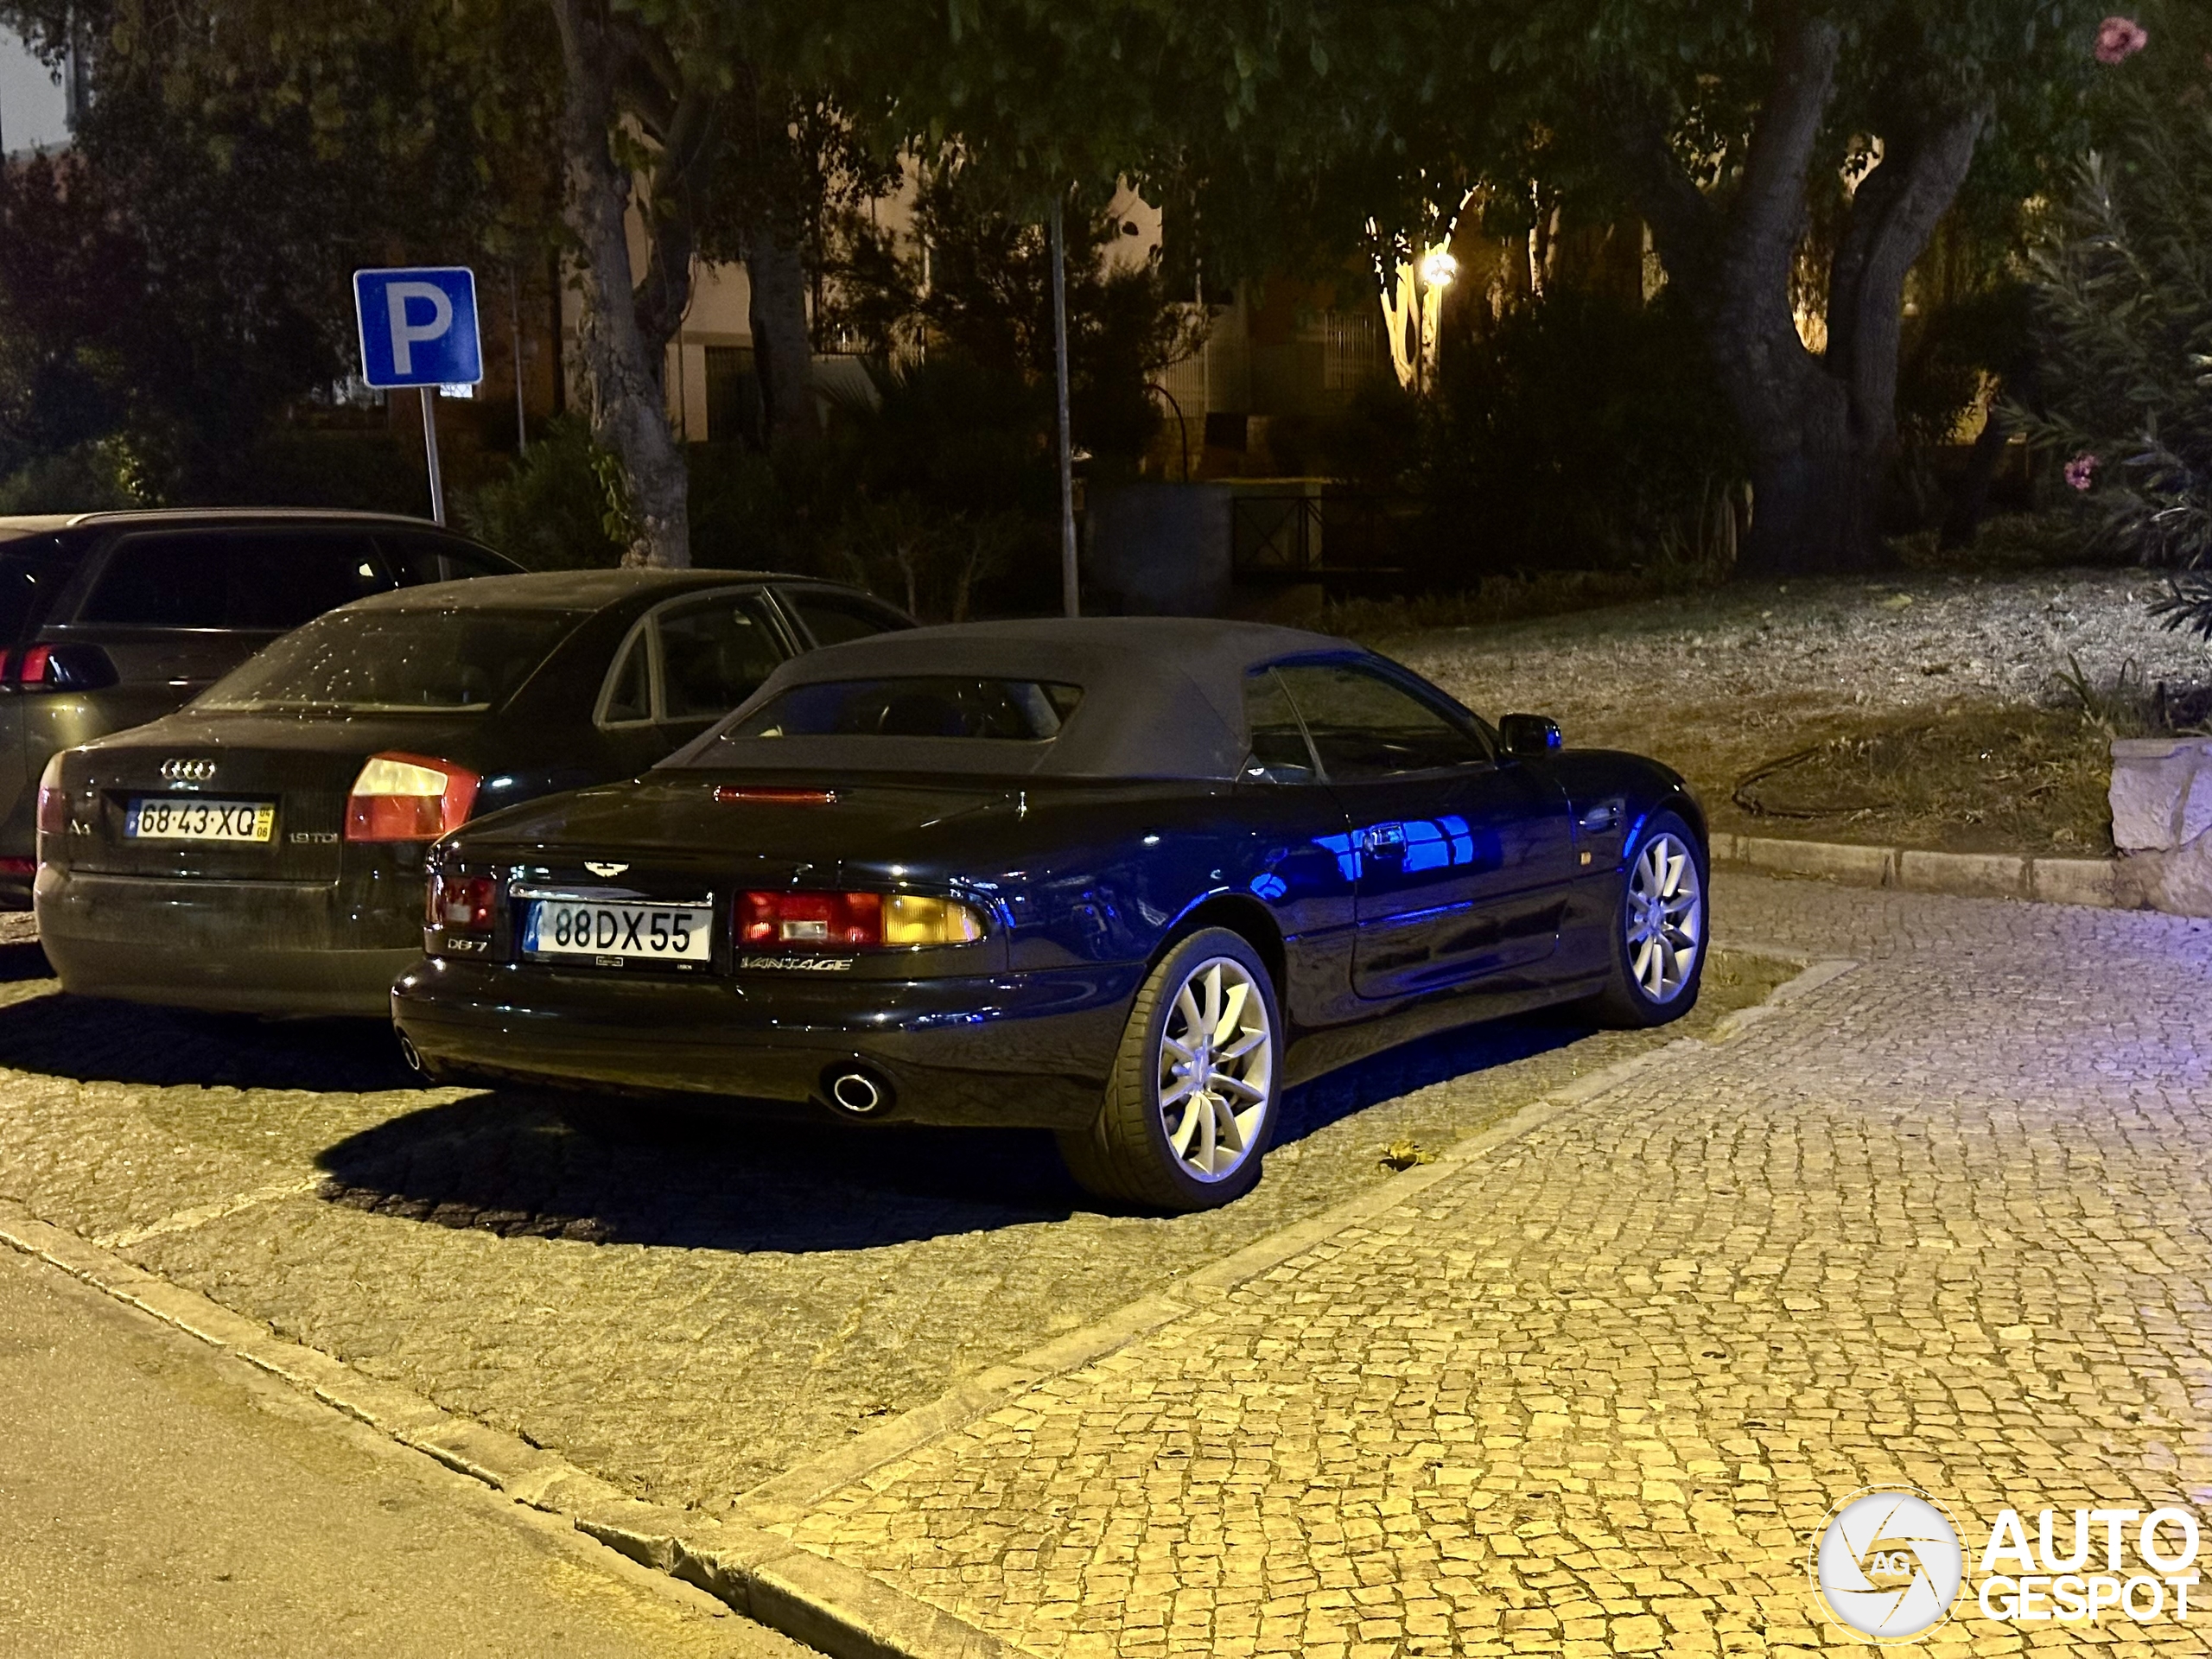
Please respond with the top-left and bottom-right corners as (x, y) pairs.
(1363, 569), (2212, 856)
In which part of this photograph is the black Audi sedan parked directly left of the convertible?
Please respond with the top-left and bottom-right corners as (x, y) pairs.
(33, 570), (913, 1018)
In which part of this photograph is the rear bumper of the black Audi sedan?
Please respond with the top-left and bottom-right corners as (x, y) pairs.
(35, 865), (423, 1020)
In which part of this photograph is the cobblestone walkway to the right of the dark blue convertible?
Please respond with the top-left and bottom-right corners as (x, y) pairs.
(785, 878), (2212, 1659)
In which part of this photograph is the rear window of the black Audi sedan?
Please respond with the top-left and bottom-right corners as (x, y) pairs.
(193, 608), (588, 715)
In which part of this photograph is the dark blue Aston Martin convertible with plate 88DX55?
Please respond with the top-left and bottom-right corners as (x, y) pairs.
(391, 617), (1706, 1210)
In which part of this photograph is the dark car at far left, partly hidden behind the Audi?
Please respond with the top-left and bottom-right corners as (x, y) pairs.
(0, 506), (522, 909)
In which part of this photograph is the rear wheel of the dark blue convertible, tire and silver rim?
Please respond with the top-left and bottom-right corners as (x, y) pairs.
(1059, 927), (1283, 1212)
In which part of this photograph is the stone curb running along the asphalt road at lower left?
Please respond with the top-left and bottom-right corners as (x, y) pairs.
(0, 1199), (1015, 1659)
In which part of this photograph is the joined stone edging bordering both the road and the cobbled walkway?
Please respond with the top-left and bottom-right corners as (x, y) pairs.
(0, 944), (1858, 1659)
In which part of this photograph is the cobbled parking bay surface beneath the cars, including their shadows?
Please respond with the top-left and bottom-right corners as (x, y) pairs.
(0, 944), (1794, 1513)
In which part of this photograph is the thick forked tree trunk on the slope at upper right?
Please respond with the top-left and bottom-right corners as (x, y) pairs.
(1619, 13), (1988, 577)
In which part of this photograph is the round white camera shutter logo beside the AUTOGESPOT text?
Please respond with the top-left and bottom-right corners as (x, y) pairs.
(1809, 1486), (1967, 1642)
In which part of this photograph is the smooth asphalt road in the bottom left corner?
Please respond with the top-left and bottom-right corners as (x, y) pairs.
(0, 1252), (807, 1659)
